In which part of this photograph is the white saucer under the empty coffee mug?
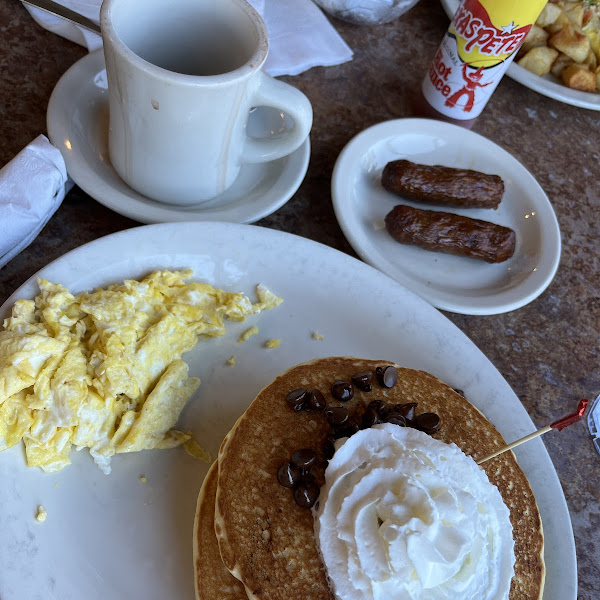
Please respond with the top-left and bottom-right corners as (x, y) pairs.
(47, 50), (310, 223)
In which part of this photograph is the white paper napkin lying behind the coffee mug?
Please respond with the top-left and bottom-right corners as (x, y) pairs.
(24, 0), (352, 77)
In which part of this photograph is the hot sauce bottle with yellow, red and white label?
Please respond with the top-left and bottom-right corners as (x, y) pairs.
(415, 0), (546, 128)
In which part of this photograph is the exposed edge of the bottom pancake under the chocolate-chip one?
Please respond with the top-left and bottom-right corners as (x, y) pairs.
(194, 462), (248, 600)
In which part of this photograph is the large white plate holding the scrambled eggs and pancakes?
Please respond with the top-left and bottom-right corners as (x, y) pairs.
(0, 222), (577, 600)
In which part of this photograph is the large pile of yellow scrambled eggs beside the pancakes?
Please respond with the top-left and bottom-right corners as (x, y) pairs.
(0, 270), (282, 473)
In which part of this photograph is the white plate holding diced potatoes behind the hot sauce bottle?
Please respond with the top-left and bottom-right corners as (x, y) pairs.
(441, 0), (600, 110)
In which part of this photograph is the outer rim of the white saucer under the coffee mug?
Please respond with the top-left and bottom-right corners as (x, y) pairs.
(46, 49), (311, 224)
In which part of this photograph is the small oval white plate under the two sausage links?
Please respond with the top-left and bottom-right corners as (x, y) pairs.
(331, 119), (561, 315)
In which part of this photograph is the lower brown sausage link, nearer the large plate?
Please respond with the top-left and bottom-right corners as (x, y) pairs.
(385, 204), (516, 263)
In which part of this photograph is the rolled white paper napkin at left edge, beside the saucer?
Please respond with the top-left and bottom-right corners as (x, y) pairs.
(0, 135), (73, 268)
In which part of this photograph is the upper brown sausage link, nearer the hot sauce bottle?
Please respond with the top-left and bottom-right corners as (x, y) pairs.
(381, 160), (504, 208)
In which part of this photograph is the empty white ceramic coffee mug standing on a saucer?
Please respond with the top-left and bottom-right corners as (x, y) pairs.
(100, 0), (312, 205)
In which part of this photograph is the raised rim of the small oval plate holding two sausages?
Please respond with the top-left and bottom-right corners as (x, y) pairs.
(331, 118), (562, 315)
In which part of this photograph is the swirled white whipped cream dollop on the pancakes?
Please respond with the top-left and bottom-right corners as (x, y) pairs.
(313, 424), (515, 600)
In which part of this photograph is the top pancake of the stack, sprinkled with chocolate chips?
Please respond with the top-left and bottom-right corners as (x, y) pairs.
(215, 357), (544, 600)
